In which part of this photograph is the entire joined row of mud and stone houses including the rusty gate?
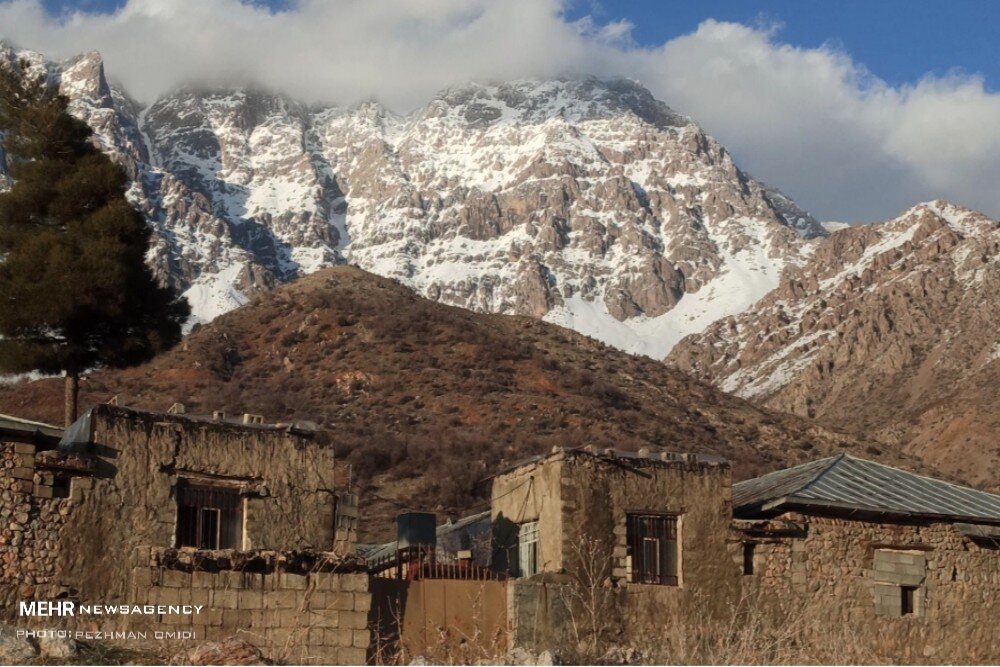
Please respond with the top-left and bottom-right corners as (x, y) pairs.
(0, 405), (1000, 664)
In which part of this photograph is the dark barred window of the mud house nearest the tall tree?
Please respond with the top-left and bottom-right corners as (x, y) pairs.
(177, 480), (243, 549)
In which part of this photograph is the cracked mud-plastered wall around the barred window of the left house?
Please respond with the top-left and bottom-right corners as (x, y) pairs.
(56, 406), (336, 601)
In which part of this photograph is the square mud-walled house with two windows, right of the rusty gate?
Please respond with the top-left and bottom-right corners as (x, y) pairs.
(491, 448), (740, 657)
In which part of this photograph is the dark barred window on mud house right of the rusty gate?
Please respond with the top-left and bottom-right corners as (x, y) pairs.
(626, 514), (680, 586)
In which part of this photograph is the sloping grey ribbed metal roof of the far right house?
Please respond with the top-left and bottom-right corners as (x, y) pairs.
(733, 454), (1000, 523)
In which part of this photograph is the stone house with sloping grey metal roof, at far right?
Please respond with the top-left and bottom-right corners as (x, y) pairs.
(733, 454), (1000, 662)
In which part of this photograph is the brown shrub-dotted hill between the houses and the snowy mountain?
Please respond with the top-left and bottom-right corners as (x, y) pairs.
(0, 267), (908, 539)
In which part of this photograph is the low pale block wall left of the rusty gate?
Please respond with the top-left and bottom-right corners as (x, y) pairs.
(123, 549), (371, 665)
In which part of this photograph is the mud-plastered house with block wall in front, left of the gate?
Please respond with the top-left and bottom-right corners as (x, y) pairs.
(0, 405), (370, 663)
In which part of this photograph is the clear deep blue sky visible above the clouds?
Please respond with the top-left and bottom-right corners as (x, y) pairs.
(43, 0), (1000, 91)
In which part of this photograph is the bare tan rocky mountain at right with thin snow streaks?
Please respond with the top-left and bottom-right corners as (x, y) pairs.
(668, 201), (1000, 485)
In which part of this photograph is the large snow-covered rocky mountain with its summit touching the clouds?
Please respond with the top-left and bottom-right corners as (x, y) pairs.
(0, 48), (828, 358)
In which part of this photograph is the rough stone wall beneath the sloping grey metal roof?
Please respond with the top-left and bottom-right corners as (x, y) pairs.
(734, 513), (1000, 663)
